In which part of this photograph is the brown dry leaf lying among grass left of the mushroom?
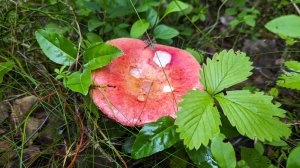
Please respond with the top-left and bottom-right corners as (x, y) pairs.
(11, 96), (38, 124)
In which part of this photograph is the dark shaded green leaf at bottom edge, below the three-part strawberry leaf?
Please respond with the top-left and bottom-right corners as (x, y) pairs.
(241, 147), (271, 168)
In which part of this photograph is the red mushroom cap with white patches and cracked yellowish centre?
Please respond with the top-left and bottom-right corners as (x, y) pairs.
(90, 38), (203, 127)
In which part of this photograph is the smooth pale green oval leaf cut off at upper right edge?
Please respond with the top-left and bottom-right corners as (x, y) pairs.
(265, 15), (300, 38)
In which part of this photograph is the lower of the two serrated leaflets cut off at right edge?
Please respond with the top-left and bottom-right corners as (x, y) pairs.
(277, 72), (300, 90)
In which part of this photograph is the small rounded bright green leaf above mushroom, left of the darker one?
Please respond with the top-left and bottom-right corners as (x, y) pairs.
(130, 19), (150, 38)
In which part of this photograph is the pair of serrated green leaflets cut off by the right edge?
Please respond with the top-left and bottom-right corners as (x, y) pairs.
(277, 61), (300, 90)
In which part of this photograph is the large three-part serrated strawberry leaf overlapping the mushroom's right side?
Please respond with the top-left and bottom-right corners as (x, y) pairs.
(175, 50), (291, 149)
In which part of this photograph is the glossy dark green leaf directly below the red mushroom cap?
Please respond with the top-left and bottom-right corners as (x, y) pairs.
(131, 117), (179, 159)
